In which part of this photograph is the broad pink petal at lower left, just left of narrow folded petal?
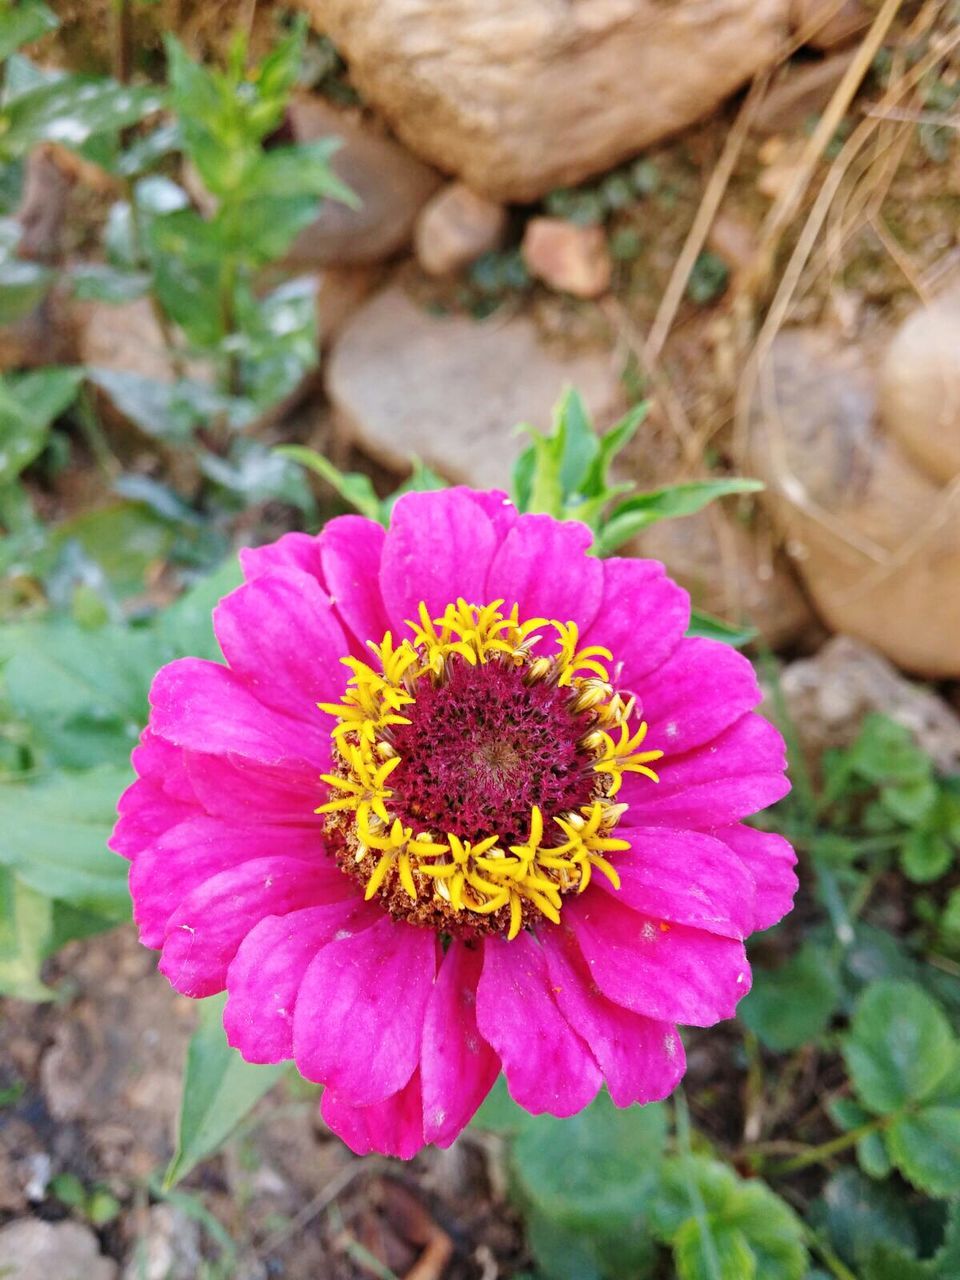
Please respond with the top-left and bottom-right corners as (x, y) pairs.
(293, 916), (436, 1106)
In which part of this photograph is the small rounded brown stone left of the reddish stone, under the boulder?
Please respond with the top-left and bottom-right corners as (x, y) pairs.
(415, 182), (507, 275)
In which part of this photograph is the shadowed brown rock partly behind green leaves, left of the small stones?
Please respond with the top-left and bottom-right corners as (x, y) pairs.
(280, 96), (440, 270)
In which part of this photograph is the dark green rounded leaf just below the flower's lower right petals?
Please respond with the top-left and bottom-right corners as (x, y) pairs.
(737, 942), (841, 1053)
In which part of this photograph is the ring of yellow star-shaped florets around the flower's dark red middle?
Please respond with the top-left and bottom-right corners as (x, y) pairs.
(316, 598), (663, 938)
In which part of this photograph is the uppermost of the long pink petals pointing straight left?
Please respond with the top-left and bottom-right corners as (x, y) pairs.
(150, 658), (330, 772)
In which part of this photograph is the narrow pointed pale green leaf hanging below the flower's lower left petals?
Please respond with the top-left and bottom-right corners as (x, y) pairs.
(164, 995), (285, 1189)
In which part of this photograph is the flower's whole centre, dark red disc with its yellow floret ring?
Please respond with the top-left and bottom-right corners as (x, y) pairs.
(317, 599), (663, 938)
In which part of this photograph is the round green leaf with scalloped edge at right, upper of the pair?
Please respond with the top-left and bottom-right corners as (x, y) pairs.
(844, 980), (955, 1115)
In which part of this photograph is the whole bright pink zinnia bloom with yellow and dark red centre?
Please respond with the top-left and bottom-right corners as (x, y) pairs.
(113, 489), (796, 1157)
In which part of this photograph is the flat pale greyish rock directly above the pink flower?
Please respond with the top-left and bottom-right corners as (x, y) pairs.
(326, 287), (621, 488)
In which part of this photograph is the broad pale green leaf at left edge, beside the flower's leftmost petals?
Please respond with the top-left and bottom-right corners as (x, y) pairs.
(0, 767), (131, 920)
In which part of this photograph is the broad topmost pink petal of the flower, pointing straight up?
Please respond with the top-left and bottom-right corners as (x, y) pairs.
(380, 489), (497, 629)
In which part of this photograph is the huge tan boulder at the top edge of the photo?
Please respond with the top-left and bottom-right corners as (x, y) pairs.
(306, 0), (790, 201)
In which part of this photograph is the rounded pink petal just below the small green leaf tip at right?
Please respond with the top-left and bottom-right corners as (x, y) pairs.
(640, 637), (762, 755)
